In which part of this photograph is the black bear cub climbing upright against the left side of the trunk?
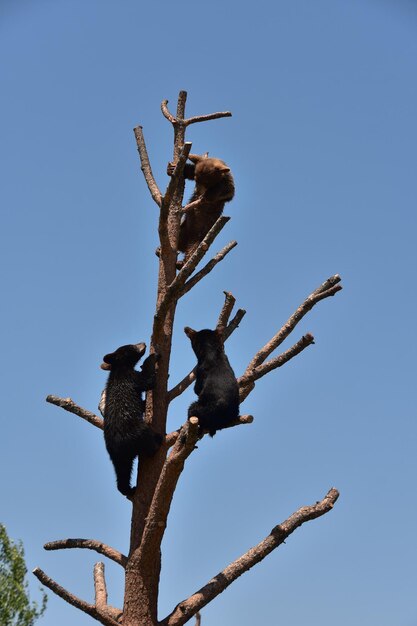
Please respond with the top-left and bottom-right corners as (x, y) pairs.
(100, 343), (162, 497)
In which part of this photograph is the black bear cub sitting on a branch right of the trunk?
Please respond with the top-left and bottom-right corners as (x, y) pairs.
(184, 326), (239, 437)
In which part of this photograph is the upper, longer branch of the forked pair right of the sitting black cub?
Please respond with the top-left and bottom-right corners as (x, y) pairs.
(244, 274), (342, 375)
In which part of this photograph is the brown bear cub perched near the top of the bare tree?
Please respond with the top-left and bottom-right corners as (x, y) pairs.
(168, 154), (235, 262)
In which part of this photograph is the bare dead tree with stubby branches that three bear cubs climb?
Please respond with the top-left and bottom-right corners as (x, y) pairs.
(34, 91), (342, 626)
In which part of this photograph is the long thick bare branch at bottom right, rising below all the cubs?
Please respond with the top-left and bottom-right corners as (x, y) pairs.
(161, 488), (339, 626)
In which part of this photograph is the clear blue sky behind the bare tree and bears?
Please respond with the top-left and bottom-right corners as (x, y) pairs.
(0, 0), (417, 626)
